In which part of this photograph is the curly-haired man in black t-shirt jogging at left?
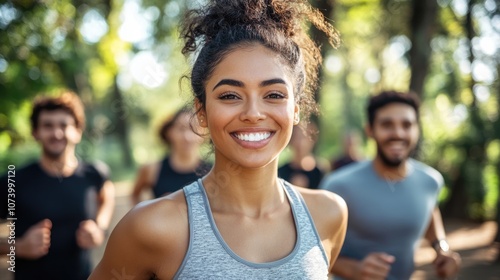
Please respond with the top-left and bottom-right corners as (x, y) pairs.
(0, 92), (114, 280)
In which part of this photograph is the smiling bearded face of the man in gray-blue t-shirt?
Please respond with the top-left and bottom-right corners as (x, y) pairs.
(368, 103), (419, 167)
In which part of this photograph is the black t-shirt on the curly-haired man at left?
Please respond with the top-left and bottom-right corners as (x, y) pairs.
(0, 162), (108, 280)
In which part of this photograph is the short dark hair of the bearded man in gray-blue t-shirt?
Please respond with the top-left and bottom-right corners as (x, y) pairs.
(367, 90), (420, 126)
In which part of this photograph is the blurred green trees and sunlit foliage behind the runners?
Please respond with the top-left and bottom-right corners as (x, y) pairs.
(0, 0), (500, 223)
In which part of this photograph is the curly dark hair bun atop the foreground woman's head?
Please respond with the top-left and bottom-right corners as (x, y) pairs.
(181, 0), (338, 53)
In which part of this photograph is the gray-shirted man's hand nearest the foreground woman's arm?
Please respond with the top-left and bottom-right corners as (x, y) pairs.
(354, 253), (396, 280)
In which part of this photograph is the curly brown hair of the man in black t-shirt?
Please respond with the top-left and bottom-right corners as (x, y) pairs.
(30, 90), (85, 131)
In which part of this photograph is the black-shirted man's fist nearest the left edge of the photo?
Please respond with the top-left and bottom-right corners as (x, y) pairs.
(17, 219), (52, 260)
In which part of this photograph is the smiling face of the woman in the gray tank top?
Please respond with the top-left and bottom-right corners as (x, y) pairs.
(198, 44), (299, 168)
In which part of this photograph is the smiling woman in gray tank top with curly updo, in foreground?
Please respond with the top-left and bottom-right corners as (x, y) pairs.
(91, 0), (347, 279)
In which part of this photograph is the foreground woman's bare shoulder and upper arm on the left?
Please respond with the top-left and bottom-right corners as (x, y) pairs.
(91, 190), (189, 279)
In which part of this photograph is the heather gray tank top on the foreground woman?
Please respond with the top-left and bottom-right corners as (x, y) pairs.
(174, 179), (328, 279)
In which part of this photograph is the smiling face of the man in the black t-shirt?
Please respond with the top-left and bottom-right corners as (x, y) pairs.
(33, 110), (82, 158)
